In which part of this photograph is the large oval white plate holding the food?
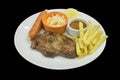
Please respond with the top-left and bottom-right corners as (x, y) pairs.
(14, 9), (106, 70)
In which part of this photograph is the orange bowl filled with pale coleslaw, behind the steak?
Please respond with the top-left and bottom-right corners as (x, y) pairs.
(42, 12), (68, 33)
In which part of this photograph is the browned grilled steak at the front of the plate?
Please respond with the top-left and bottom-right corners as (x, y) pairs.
(31, 32), (76, 58)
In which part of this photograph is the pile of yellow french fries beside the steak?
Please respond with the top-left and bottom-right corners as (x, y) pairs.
(72, 20), (108, 58)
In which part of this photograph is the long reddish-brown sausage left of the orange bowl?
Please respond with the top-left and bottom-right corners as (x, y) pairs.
(28, 10), (47, 40)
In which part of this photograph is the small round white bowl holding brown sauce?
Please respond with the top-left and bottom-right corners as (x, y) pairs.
(67, 18), (87, 37)
